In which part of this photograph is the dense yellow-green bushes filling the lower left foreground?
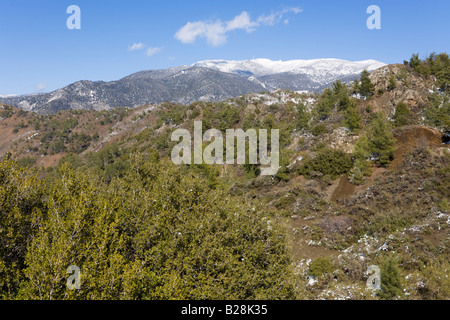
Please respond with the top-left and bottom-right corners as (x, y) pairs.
(0, 158), (295, 299)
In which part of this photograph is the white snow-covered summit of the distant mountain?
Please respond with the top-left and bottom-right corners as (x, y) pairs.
(193, 59), (385, 84)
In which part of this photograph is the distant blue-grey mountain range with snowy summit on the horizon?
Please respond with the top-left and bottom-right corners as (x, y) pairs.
(0, 59), (385, 114)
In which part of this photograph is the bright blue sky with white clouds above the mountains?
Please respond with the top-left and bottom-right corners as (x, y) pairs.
(0, 0), (450, 95)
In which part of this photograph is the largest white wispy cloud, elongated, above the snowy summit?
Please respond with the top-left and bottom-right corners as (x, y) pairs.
(175, 8), (302, 47)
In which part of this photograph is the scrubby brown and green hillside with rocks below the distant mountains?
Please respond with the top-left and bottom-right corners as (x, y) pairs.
(0, 54), (450, 299)
